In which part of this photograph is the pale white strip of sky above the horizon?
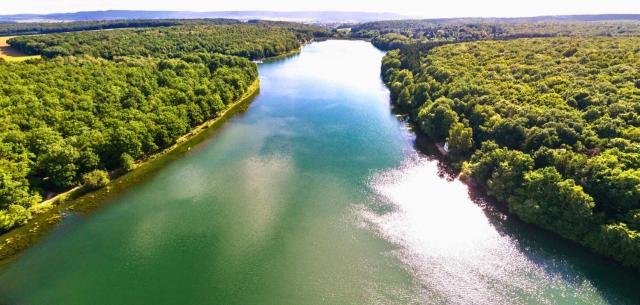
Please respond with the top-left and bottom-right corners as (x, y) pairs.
(0, 0), (640, 18)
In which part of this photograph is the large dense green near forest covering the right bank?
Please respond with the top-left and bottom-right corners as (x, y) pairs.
(382, 37), (640, 268)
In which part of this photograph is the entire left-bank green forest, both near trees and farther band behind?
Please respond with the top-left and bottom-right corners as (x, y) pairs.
(0, 21), (325, 232)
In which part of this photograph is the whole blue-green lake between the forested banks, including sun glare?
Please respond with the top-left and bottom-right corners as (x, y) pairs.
(0, 41), (640, 305)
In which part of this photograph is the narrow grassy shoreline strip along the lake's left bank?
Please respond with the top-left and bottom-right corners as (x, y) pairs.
(0, 80), (260, 269)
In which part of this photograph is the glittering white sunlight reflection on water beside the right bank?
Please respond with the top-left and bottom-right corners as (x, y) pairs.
(357, 156), (606, 304)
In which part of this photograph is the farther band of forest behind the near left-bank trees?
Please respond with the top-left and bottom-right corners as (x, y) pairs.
(9, 22), (324, 59)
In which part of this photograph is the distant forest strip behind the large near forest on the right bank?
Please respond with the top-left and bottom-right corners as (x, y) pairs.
(351, 19), (640, 50)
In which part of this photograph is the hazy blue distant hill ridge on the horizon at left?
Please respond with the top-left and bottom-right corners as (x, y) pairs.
(0, 10), (409, 23)
